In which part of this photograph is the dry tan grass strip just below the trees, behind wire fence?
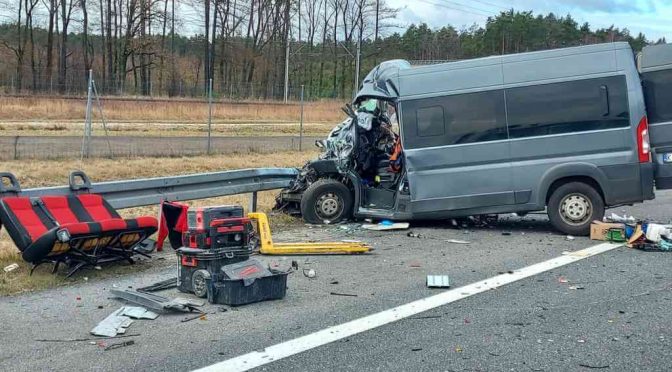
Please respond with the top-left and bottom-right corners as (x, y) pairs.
(0, 97), (344, 137)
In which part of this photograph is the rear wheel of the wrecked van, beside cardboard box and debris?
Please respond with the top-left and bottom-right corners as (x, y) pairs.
(548, 182), (604, 236)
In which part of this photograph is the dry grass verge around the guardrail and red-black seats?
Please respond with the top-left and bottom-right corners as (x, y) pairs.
(0, 150), (317, 295)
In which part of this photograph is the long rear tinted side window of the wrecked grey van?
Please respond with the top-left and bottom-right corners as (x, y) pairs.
(506, 76), (630, 138)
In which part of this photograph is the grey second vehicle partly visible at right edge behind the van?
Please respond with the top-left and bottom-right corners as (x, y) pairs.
(639, 44), (672, 189)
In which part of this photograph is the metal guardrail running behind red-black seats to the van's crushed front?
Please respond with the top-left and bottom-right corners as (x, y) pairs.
(0, 168), (298, 211)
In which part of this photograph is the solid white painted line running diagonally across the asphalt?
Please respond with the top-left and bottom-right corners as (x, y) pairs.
(196, 243), (623, 372)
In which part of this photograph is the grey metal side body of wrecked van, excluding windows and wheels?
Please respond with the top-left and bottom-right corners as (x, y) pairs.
(356, 43), (656, 218)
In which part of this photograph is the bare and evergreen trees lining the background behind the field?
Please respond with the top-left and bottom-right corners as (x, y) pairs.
(0, 0), (665, 99)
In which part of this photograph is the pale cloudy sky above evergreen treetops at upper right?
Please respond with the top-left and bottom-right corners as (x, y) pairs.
(387, 0), (672, 42)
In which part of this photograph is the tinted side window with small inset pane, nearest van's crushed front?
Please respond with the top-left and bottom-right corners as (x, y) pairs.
(402, 90), (507, 149)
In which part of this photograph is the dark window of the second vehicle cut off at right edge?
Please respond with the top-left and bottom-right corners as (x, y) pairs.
(642, 69), (672, 124)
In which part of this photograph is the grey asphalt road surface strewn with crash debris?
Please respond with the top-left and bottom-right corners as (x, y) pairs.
(0, 193), (672, 371)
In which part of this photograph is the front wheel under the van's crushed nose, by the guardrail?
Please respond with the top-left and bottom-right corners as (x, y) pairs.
(301, 178), (353, 224)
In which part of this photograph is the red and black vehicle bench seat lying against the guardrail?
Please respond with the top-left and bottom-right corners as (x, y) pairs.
(0, 172), (158, 276)
